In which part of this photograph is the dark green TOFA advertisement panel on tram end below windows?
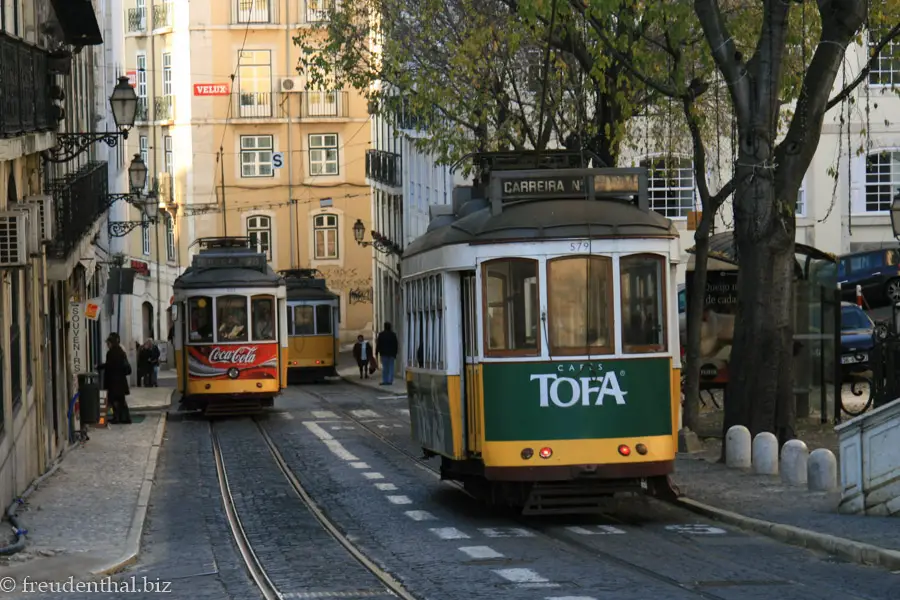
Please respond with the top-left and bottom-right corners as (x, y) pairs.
(483, 358), (672, 442)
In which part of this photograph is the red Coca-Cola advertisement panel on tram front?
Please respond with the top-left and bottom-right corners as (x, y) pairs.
(188, 343), (278, 379)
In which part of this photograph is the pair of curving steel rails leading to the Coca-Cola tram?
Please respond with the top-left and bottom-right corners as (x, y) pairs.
(209, 418), (419, 600)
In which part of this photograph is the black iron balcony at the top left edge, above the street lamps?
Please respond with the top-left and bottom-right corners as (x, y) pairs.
(0, 33), (56, 137)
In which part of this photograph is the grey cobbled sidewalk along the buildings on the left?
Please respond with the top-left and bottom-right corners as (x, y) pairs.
(0, 380), (174, 596)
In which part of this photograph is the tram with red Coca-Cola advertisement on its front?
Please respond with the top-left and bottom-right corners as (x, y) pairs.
(172, 237), (288, 414)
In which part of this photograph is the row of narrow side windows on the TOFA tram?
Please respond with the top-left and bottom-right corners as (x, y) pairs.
(405, 274), (444, 369)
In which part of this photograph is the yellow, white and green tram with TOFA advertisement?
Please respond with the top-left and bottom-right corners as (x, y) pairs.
(401, 152), (681, 514)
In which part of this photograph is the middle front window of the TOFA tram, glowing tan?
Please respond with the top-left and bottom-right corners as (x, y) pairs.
(547, 256), (615, 355)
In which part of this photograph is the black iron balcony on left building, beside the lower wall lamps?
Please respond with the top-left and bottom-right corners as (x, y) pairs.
(47, 162), (109, 260)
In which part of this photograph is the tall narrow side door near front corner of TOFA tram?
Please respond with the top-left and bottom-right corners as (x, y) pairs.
(460, 271), (482, 454)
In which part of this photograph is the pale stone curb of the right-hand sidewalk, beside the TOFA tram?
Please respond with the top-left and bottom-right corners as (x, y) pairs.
(674, 498), (900, 571)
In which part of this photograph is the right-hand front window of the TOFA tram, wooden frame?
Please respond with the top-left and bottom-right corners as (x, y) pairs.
(619, 254), (666, 353)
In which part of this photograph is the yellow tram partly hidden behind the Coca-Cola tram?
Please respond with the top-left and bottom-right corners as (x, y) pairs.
(280, 269), (341, 382)
